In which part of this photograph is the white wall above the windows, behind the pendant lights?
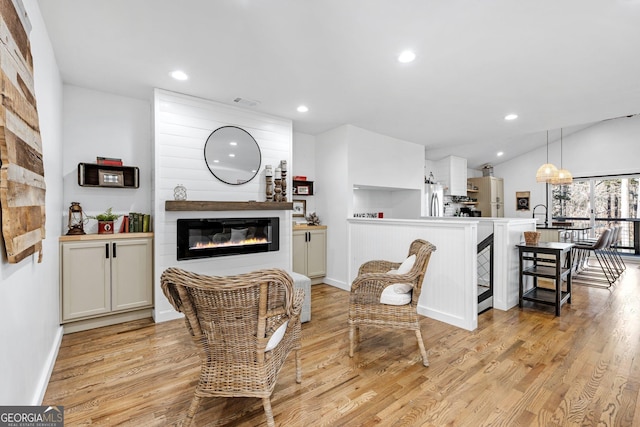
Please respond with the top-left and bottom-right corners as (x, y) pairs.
(494, 116), (640, 220)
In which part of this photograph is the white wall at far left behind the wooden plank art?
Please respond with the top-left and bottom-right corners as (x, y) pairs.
(0, 0), (66, 405)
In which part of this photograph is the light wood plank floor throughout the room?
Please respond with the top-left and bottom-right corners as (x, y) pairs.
(44, 264), (640, 427)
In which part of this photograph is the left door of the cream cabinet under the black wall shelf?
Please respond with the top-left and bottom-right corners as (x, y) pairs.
(60, 241), (111, 321)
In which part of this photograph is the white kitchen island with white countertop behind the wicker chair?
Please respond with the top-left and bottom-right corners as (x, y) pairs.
(348, 217), (535, 330)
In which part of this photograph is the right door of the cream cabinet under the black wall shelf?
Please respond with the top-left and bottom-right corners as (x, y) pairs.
(110, 239), (153, 311)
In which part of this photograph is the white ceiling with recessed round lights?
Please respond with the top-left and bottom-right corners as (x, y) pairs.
(39, 0), (640, 167)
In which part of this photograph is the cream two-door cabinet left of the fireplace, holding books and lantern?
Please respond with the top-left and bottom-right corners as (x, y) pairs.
(60, 233), (153, 331)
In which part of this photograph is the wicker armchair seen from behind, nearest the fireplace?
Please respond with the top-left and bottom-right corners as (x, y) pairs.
(160, 268), (304, 426)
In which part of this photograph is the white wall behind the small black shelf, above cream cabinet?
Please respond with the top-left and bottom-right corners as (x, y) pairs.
(62, 85), (151, 234)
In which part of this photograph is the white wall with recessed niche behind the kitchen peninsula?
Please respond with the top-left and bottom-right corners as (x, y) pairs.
(316, 125), (424, 288)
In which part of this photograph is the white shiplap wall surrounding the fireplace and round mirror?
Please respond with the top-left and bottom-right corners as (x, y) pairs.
(152, 89), (292, 322)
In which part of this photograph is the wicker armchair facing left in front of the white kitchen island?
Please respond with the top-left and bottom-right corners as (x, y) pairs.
(349, 239), (436, 366)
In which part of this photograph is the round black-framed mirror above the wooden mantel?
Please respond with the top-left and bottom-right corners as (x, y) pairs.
(204, 126), (261, 185)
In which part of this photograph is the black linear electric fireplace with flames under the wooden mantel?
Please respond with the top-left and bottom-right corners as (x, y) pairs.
(177, 217), (280, 261)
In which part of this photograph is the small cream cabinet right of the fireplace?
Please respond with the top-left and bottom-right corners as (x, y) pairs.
(293, 225), (327, 283)
